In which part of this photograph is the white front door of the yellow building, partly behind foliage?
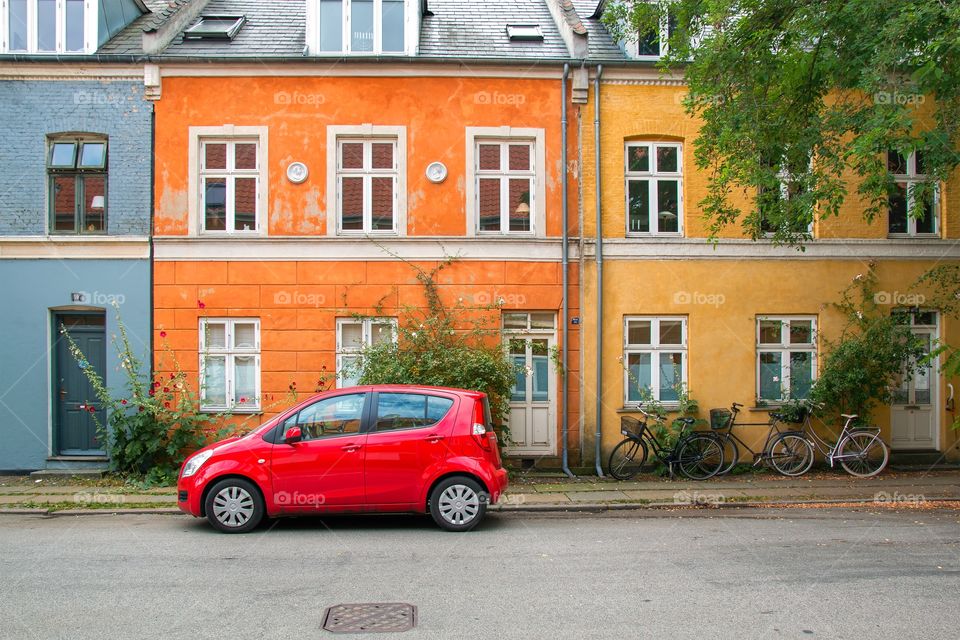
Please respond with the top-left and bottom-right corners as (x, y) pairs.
(890, 327), (938, 449)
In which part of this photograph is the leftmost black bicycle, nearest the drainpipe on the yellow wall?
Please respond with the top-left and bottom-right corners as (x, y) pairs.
(607, 409), (723, 480)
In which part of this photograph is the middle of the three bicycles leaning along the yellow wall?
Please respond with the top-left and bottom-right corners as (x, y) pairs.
(710, 402), (813, 476)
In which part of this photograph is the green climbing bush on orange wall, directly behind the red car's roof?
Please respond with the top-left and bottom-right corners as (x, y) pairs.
(354, 260), (516, 441)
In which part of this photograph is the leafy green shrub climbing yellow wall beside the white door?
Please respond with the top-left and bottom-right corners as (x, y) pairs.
(810, 266), (924, 422)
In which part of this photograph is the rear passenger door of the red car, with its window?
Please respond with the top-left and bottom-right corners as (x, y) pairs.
(364, 392), (458, 511)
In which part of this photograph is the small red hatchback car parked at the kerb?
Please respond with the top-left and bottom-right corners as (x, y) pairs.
(177, 385), (507, 533)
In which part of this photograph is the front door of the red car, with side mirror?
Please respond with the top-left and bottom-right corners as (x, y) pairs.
(270, 393), (368, 513)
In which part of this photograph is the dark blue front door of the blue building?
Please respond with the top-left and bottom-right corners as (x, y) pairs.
(53, 313), (107, 456)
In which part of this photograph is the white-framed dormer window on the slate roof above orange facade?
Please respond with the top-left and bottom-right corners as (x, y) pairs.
(308, 0), (407, 55)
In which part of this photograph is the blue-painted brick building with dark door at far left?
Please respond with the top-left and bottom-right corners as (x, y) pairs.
(0, 0), (159, 471)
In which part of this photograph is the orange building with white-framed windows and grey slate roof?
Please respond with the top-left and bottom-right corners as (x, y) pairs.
(145, 0), (600, 466)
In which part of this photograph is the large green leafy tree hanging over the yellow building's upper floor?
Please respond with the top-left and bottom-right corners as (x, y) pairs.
(604, 0), (960, 248)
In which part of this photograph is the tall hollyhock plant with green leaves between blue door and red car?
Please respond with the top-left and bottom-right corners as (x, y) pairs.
(60, 310), (231, 484)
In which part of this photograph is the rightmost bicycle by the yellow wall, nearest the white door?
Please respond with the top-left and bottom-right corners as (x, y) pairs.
(798, 405), (890, 478)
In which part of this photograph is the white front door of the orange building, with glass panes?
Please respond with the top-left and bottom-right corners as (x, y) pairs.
(507, 333), (557, 456)
